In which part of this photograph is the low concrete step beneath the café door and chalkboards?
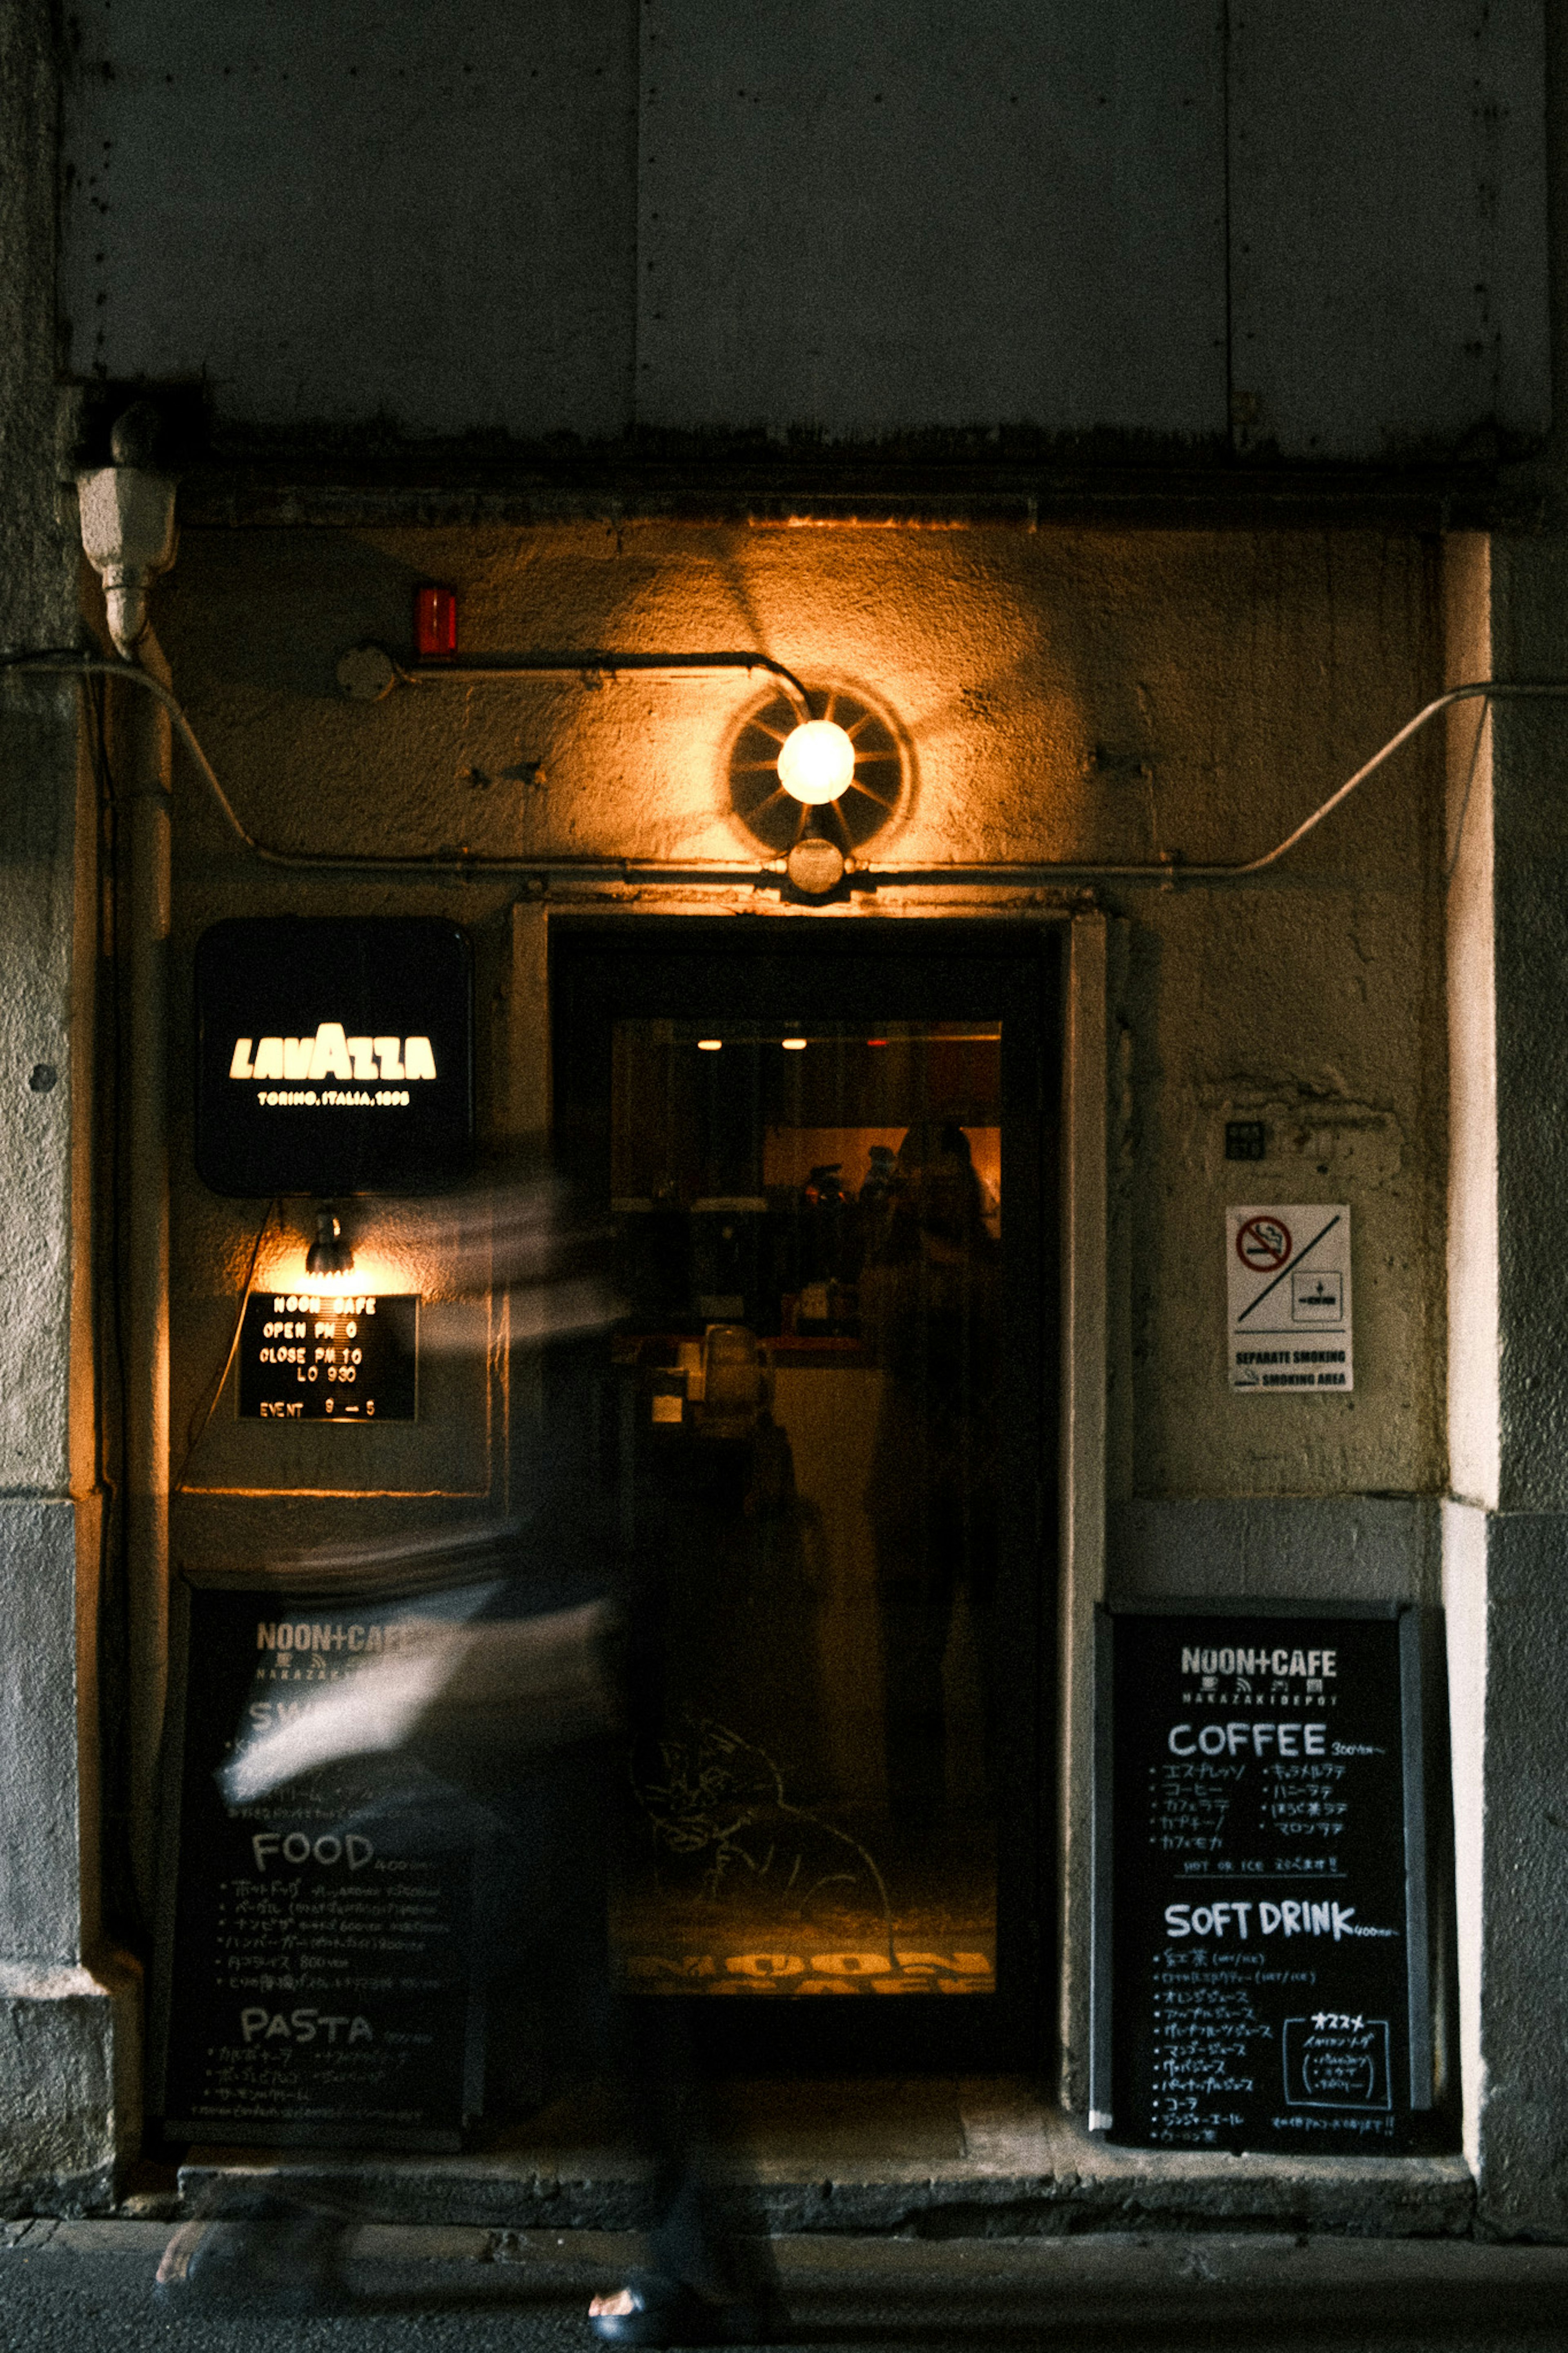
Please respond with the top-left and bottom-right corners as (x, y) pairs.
(160, 2075), (1476, 2240)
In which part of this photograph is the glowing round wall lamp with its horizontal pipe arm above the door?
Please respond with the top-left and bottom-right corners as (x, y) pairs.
(339, 645), (907, 899)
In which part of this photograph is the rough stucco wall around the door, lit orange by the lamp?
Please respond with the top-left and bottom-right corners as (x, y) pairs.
(160, 525), (1446, 1525)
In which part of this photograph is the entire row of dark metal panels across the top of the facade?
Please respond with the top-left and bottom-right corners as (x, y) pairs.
(63, 0), (1547, 459)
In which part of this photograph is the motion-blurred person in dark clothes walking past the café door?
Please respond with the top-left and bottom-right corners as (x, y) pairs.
(158, 1186), (776, 2346)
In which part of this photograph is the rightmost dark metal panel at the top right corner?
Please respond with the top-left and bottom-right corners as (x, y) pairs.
(1229, 0), (1549, 459)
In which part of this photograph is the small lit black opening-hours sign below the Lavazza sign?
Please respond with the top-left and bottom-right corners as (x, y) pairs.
(240, 1289), (419, 1421)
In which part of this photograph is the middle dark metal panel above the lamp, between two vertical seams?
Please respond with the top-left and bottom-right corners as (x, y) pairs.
(637, 0), (1225, 438)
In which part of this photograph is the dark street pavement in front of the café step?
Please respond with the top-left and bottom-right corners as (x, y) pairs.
(0, 2221), (1568, 2353)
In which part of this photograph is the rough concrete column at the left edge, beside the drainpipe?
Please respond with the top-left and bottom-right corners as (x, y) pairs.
(0, 0), (139, 2212)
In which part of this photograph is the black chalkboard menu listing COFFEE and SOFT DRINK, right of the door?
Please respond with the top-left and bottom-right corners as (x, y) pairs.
(1091, 1605), (1434, 2155)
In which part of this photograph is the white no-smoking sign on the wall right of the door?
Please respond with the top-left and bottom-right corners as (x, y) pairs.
(1225, 1202), (1356, 1395)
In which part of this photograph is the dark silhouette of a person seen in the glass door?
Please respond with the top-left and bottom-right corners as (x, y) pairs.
(860, 1120), (1002, 1856)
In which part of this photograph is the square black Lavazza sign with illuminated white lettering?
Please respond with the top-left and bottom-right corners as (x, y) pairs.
(195, 915), (472, 1198)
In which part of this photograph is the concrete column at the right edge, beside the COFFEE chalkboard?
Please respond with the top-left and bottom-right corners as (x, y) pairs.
(1443, 532), (1568, 2238)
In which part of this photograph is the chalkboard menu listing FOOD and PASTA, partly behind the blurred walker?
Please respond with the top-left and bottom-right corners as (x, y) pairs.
(153, 1584), (482, 2148)
